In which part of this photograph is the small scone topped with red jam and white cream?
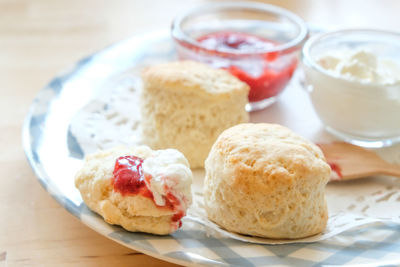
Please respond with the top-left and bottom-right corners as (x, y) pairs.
(75, 146), (193, 235)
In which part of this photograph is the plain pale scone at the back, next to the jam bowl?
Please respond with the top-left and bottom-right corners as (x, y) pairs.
(141, 61), (249, 168)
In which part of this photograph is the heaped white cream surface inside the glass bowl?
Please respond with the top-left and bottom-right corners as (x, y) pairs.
(317, 48), (400, 85)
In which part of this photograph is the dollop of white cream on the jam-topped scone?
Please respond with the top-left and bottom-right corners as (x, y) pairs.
(142, 149), (193, 210)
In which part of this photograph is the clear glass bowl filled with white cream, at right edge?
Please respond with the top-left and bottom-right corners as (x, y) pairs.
(302, 29), (400, 148)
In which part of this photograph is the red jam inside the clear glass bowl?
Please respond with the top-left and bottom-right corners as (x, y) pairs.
(197, 32), (297, 102)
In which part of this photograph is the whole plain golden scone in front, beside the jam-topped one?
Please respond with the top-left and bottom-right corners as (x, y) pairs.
(204, 123), (330, 239)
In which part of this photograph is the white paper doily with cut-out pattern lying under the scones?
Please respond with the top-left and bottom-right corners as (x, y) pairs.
(70, 70), (400, 244)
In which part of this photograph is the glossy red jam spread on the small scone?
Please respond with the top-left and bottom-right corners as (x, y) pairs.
(112, 156), (185, 227)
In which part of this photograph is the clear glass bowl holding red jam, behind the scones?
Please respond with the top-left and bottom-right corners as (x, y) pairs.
(171, 2), (308, 111)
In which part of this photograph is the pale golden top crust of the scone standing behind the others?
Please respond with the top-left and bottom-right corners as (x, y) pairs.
(142, 61), (249, 95)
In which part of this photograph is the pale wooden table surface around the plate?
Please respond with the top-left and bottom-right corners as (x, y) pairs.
(0, 0), (400, 267)
